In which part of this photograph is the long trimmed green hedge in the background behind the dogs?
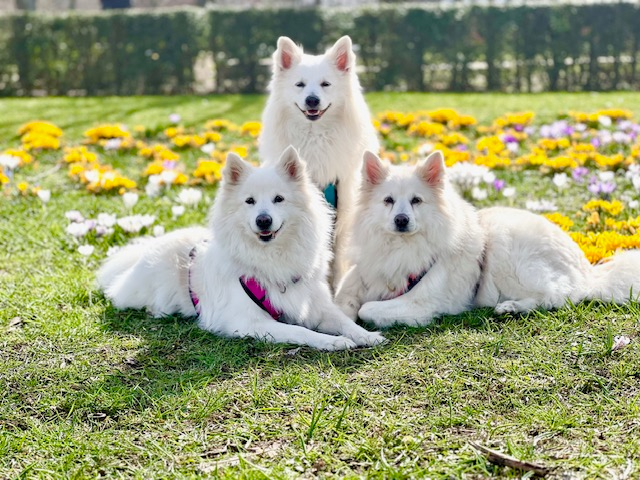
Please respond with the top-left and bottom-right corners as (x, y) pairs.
(0, 3), (640, 95)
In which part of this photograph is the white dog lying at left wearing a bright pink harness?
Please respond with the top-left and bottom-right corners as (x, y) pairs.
(98, 147), (384, 350)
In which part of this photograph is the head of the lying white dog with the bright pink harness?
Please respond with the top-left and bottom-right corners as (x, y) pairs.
(214, 146), (308, 246)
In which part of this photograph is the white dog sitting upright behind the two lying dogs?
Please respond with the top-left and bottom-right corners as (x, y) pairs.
(259, 36), (379, 281)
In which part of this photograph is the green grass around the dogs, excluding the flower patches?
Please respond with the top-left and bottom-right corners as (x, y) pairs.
(0, 93), (640, 479)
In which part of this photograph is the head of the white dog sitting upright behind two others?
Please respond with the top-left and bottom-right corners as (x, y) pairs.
(271, 36), (355, 121)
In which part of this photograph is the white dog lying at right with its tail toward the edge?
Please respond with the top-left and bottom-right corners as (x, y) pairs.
(336, 151), (640, 327)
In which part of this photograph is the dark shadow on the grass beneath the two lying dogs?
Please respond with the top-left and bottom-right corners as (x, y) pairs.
(98, 294), (499, 382)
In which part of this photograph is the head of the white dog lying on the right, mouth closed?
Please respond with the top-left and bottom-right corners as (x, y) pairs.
(358, 151), (447, 236)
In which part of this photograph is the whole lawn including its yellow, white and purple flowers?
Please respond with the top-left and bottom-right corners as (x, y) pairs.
(0, 93), (640, 478)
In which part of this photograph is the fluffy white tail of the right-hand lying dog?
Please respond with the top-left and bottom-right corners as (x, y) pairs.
(587, 250), (640, 304)
